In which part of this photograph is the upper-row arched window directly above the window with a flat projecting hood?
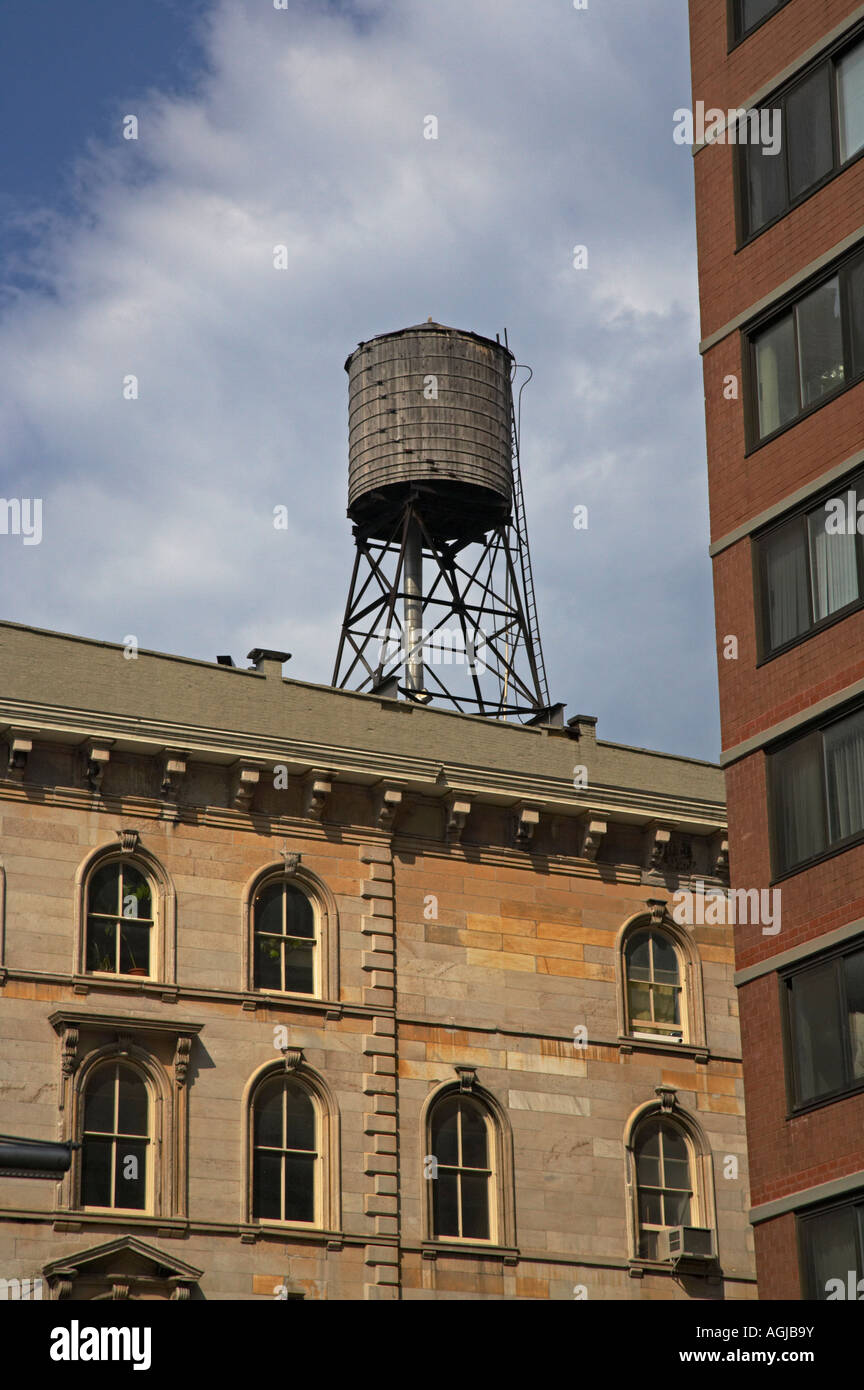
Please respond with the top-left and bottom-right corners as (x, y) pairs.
(85, 859), (156, 976)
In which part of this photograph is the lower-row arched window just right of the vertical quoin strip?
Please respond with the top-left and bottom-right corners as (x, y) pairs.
(429, 1095), (496, 1240)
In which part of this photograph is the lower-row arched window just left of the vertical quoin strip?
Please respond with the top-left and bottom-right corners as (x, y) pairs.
(251, 1076), (321, 1223)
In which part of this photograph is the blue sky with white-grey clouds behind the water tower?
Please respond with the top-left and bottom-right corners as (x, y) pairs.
(0, 0), (718, 759)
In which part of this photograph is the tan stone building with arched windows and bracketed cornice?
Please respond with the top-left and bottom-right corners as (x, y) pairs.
(0, 623), (756, 1300)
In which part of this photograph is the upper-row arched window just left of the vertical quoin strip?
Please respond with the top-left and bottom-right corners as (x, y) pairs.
(253, 878), (319, 994)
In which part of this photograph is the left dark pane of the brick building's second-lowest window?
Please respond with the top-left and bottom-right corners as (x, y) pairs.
(789, 962), (845, 1102)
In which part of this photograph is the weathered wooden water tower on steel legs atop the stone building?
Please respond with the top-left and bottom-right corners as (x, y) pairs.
(333, 320), (561, 723)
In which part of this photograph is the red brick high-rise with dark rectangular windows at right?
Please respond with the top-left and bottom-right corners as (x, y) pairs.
(690, 0), (864, 1300)
